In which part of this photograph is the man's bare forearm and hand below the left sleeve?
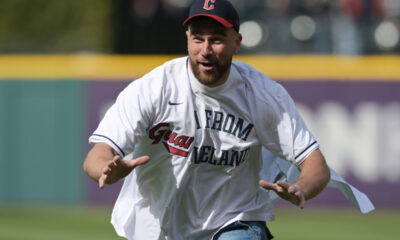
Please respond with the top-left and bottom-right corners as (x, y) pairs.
(83, 143), (150, 188)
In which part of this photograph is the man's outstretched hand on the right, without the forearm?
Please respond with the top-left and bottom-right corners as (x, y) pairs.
(259, 180), (306, 209)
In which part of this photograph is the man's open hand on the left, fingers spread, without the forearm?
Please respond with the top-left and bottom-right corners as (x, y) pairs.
(99, 155), (150, 188)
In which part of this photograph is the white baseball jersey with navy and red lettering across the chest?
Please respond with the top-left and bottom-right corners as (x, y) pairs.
(89, 57), (318, 240)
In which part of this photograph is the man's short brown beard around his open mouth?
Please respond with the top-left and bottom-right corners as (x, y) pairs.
(189, 54), (232, 87)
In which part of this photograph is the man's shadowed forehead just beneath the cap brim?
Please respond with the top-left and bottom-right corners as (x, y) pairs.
(188, 17), (229, 35)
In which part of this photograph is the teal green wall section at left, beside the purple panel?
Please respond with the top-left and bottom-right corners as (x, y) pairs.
(0, 79), (85, 203)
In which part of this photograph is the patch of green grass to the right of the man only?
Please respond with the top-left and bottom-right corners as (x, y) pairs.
(268, 207), (400, 240)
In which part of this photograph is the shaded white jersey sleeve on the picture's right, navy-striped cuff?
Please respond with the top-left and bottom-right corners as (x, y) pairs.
(250, 74), (319, 165)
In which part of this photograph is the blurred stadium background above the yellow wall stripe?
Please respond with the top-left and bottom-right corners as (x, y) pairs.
(0, 0), (400, 55)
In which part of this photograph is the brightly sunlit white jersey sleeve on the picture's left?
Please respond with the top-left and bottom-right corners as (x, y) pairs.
(89, 79), (153, 156)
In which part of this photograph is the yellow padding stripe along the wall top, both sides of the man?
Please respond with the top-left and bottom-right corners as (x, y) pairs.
(0, 55), (400, 81)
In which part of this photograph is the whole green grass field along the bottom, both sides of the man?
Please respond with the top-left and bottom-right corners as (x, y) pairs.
(0, 206), (400, 240)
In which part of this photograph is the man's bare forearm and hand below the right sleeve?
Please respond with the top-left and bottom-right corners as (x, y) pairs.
(260, 149), (330, 208)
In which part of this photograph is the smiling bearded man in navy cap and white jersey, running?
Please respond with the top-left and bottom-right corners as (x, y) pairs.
(84, 0), (330, 240)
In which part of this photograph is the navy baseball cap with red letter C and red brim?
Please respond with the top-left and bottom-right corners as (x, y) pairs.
(183, 0), (239, 32)
